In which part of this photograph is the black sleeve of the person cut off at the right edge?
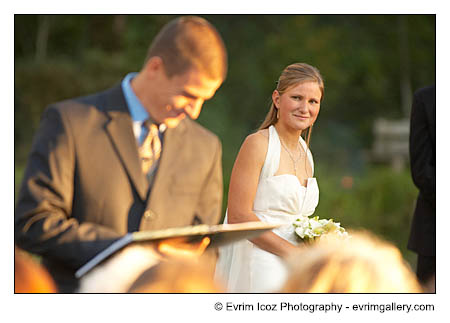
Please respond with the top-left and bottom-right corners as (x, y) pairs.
(409, 91), (436, 203)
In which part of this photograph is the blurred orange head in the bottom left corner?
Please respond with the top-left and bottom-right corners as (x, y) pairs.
(14, 248), (58, 293)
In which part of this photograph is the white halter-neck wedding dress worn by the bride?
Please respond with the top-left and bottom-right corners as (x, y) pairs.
(216, 126), (319, 293)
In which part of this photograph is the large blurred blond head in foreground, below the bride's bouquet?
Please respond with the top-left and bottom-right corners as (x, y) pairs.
(281, 232), (422, 293)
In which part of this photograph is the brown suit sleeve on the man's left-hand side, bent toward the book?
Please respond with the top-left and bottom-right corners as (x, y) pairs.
(15, 107), (119, 269)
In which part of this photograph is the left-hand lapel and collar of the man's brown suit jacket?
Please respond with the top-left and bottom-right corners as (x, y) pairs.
(104, 86), (149, 201)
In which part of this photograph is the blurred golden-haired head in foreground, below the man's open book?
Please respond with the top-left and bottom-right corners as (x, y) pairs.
(128, 260), (223, 293)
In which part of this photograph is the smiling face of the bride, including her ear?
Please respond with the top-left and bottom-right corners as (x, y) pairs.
(272, 81), (322, 130)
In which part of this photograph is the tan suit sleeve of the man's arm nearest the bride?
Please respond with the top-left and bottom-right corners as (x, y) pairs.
(196, 139), (223, 224)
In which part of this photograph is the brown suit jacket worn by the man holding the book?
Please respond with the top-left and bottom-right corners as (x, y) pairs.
(15, 85), (222, 292)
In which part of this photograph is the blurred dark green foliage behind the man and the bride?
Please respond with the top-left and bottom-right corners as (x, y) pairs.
(14, 15), (436, 266)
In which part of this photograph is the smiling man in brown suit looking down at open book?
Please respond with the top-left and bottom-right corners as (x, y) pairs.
(15, 17), (227, 292)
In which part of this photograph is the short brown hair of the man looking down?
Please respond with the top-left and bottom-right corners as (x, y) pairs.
(145, 16), (228, 81)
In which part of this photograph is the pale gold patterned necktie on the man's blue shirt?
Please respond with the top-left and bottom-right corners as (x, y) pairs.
(139, 121), (161, 176)
